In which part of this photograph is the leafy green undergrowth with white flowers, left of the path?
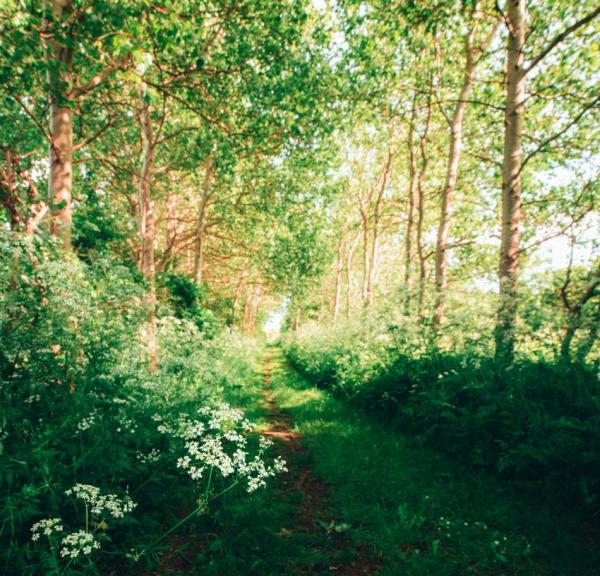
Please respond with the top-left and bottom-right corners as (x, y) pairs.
(0, 238), (282, 576)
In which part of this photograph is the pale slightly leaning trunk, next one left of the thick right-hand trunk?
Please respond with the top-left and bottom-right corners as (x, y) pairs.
(433, 8), (479, 326)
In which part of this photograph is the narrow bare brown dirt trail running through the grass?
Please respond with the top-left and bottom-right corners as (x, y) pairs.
(262, 349), (379, 576)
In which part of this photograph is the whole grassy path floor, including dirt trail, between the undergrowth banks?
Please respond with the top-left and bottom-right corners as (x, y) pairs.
(151, 348), (600, 576)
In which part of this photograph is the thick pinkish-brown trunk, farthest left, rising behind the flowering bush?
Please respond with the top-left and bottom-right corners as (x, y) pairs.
(45, 0), (73, 250)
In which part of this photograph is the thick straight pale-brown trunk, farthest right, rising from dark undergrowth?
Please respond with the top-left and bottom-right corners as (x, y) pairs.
(495, 0), (526, 363)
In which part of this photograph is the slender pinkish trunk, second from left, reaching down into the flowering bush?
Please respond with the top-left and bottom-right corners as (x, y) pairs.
(139, 85), (158, 370)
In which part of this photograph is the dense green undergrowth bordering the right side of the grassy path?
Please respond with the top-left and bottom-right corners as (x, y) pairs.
(285, 318), (600, 513)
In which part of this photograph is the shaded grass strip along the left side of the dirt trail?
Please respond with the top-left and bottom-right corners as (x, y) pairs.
(188, 346), (354, 576)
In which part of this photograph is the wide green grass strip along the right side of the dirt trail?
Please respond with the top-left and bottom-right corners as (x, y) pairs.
(273, 360), (599, 576)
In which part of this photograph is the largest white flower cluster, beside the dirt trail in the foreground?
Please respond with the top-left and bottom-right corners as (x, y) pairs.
(172, 403), (287, 492)
